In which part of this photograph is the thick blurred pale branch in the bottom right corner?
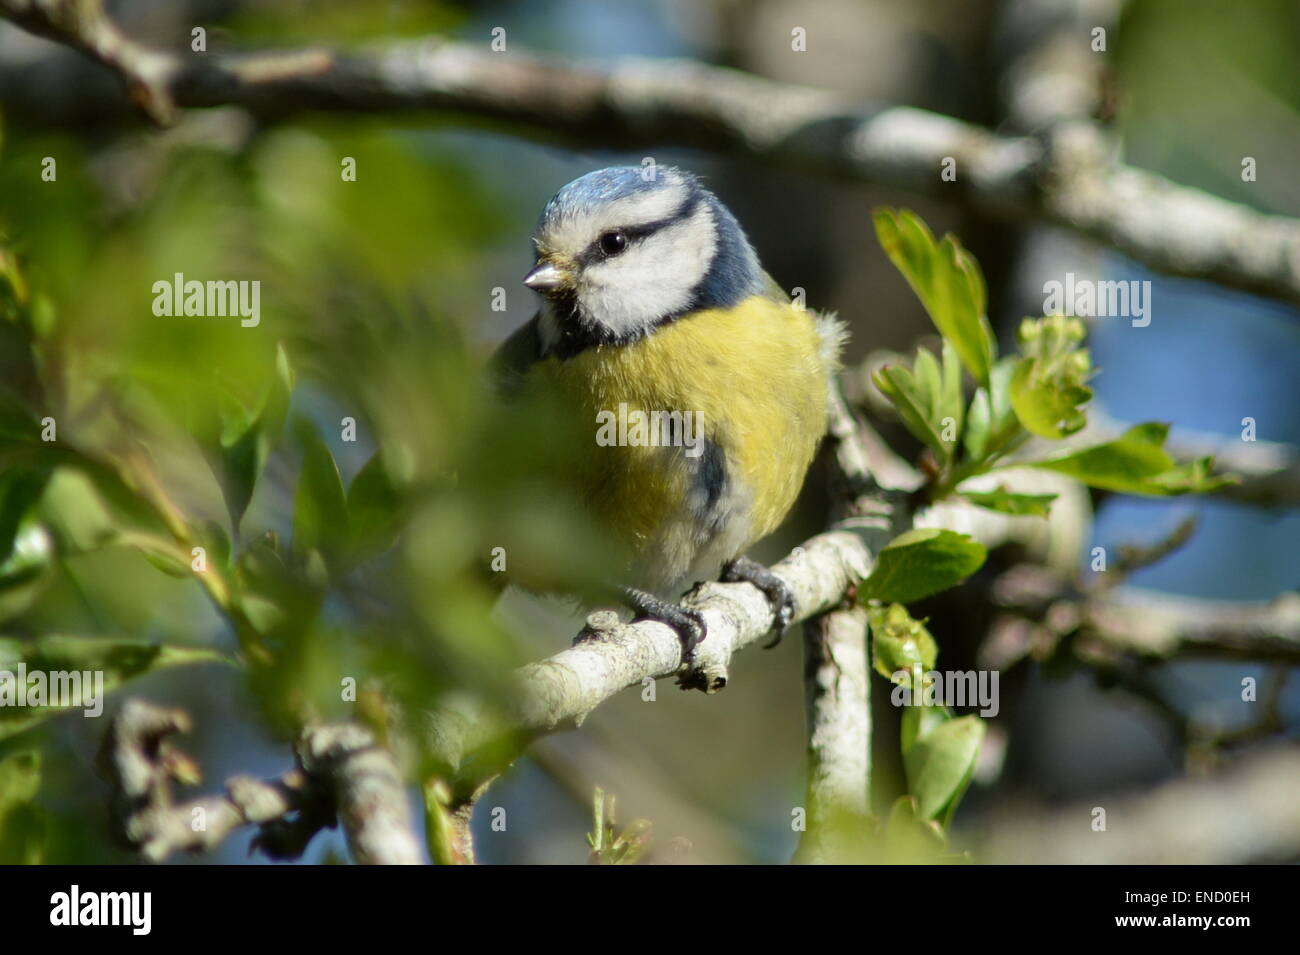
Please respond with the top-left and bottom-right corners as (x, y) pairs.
(976, 747), (1300, 865)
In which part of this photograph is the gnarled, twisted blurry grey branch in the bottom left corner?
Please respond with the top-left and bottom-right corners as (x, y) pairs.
(99, 699), (421, 864)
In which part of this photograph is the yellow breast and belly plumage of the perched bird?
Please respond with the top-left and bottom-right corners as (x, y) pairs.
(532, 296), (828, 546)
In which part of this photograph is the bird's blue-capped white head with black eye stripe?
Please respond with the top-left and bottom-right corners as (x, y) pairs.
(524, 166), (763, 356)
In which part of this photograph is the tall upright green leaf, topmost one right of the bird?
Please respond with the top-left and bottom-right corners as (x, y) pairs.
(875, 209), (997, 385)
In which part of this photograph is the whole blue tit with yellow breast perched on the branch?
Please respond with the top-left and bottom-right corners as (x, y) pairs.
(494, 166), (842, 655)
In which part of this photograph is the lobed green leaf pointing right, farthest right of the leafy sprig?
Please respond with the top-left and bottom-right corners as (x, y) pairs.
(1027, 421), (1239, 496)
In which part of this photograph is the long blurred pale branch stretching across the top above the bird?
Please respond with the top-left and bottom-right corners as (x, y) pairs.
(0, 0), (1300, 303)
